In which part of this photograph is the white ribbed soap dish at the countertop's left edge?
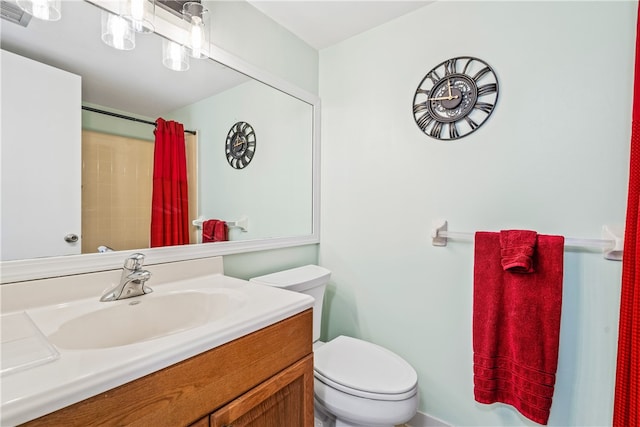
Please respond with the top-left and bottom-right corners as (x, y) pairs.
(0, 312), (60, 376)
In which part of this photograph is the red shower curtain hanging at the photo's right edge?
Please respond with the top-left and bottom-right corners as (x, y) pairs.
(613, 2), (640, 427)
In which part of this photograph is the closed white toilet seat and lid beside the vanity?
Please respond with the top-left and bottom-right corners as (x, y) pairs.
(314, 336), (418, 401)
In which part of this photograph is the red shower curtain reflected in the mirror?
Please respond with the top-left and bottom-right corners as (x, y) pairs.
(151, 118), (189, 248)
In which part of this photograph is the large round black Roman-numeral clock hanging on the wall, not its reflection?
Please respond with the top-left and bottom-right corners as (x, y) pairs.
(413, 56), (498, 140)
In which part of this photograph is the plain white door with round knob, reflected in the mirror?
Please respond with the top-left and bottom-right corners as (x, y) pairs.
(0, 50), (82, 261)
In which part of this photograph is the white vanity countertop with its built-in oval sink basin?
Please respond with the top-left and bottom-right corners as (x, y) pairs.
(0, 272), (313, 426)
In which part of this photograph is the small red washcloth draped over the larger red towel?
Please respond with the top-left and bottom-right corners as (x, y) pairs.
(500, 230), (538, 273)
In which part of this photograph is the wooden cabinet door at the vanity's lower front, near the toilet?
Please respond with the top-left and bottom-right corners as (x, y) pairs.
(210, 355), (313, 427)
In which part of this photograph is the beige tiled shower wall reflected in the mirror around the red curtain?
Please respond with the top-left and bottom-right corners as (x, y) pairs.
(82, 130), (198, 253)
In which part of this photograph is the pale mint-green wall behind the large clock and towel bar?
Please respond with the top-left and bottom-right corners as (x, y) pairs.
(320, 1), (636, 426)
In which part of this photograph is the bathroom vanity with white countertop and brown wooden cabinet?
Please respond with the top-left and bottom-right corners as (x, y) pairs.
(0, 257), (313, 426)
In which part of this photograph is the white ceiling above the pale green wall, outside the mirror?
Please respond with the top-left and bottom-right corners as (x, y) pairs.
(247, 0), (434, 50)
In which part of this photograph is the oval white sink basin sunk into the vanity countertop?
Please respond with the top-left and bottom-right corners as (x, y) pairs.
(48, 291), (243, 349)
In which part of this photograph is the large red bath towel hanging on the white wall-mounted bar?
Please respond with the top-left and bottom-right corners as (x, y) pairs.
(473, 232), (564, 424)
